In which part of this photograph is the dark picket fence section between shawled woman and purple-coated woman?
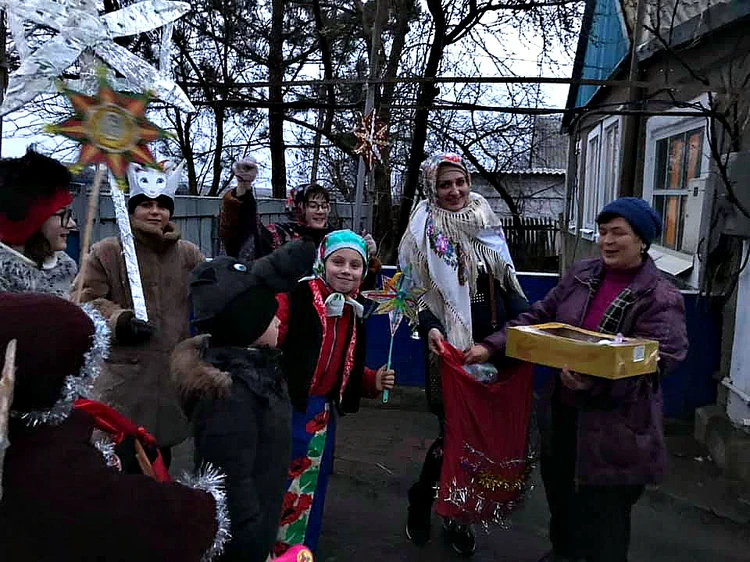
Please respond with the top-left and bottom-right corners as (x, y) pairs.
(500, 216), (560, 272)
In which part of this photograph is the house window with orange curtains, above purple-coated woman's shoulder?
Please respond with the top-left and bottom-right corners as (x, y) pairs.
(653, 127), (704, 250)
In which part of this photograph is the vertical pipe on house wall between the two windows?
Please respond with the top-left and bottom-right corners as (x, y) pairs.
(619, 0), (647, 197)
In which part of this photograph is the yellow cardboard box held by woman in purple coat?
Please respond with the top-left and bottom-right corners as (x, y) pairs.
(505, 322), (659, 379)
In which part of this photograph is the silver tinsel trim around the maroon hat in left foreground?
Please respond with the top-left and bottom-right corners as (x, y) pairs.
(10, 304), (110, 427)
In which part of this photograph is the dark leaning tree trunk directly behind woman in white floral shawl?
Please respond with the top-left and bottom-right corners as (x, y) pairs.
(396, 0), (445, 239)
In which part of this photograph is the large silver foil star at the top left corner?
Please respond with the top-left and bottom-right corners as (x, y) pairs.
(0, 0), (195, 116)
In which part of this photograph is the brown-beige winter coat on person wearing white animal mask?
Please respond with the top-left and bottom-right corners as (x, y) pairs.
(75, 217), (204, 447)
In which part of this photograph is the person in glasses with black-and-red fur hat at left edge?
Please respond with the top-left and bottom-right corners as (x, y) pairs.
(0, 149), (77, 298)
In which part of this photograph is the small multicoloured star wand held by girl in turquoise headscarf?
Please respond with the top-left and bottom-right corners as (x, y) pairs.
(362, 270), (425, 403)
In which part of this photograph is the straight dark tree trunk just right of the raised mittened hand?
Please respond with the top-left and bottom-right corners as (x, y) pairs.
(268, 0), (286, 199)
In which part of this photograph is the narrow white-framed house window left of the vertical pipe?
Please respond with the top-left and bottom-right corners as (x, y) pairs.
(583, 117), (622, 233)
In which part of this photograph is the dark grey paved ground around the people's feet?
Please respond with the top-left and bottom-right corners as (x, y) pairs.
(317, 402), (750, 562)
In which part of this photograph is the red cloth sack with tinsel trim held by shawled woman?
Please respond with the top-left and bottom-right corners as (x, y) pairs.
(436, 344), (533, 525)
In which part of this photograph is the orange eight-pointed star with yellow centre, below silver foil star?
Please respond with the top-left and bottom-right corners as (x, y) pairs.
(44, 74), (169, 190)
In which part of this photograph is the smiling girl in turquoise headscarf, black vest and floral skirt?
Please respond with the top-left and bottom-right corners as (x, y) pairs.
(275, 230), (395, 554)
